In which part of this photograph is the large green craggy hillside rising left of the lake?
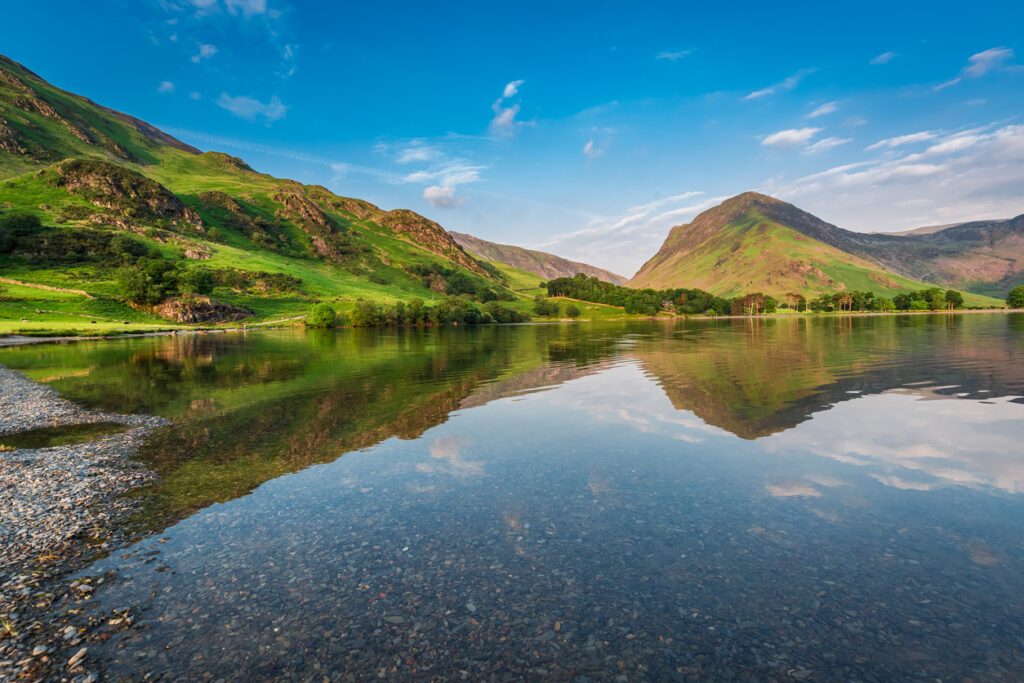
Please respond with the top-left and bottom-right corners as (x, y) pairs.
(0, 56), (505, 324)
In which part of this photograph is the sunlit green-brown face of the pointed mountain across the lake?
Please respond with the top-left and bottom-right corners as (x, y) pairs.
(628, 193), (995, 305)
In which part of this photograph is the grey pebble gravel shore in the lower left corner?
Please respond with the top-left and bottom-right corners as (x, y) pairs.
(0, 366), (169, 681)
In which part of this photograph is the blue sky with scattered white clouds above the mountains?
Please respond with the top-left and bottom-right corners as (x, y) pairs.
(0, 0), (1024, 275)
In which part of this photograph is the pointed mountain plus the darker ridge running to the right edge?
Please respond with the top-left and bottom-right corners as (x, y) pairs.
(629, 193), (1024, 303)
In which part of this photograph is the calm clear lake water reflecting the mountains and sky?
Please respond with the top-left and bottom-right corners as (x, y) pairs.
(0, 314), (1024, 681)
